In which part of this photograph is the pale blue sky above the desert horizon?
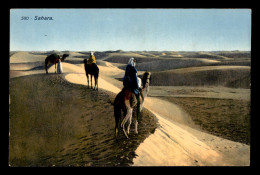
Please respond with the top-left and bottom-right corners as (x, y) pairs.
(10, 9), (251, 51)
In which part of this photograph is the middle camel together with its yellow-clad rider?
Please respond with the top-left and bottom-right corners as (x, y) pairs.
(83, 52), (99, 90)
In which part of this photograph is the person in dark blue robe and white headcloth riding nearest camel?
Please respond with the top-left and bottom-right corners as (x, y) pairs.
(123, 58), (141, 120)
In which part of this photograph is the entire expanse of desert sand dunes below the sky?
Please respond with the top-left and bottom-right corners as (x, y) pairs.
(9, 50), (251, 166)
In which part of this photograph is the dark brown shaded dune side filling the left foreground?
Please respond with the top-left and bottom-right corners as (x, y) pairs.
(8, 74), (156, 167)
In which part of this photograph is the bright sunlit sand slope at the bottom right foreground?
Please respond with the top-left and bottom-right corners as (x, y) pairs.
(134, 109), (250, 166)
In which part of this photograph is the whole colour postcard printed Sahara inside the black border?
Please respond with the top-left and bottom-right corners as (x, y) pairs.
(8, 8), (252, 167)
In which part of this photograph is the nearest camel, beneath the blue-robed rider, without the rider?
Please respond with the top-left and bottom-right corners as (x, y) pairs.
(114, 72), (151, 139)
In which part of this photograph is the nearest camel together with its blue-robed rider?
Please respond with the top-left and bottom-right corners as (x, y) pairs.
(114, 58), (151, 139)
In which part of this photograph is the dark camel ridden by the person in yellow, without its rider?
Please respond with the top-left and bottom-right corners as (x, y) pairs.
(83, 59), (99, 91)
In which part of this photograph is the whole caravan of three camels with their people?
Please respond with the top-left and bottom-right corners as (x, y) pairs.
(45, 52), (151, 139)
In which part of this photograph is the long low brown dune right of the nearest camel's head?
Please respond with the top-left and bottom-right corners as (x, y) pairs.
(152, 66), (250, 89)
